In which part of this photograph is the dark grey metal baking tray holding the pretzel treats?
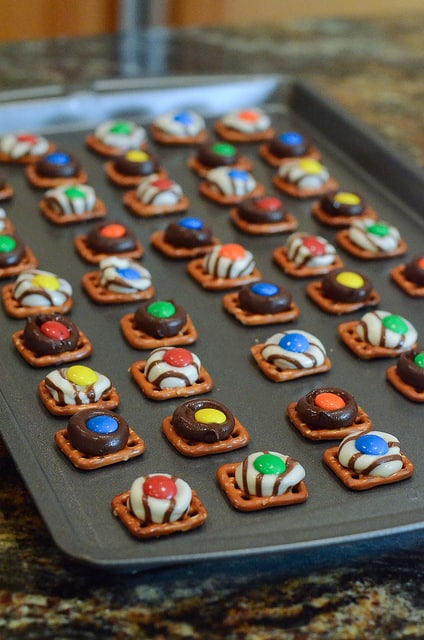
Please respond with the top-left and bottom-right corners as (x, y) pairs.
(0, 75), (424, 571)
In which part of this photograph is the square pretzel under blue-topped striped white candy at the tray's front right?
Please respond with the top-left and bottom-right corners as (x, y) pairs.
(323, 447), (414, 491)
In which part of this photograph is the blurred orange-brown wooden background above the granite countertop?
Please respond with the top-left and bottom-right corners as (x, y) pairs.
(0, 0), (424, 42)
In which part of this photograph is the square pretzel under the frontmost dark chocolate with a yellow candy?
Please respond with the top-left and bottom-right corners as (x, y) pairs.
(162, 416), (250, 458)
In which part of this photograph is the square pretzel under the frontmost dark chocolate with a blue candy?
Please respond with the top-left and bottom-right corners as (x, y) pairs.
(55, 428), (145, 471)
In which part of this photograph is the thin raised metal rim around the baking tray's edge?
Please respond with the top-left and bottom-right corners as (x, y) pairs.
(0, 74), (424, 571)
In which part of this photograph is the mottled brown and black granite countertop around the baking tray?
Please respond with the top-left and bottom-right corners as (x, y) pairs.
(0, 13), (424, 640)
